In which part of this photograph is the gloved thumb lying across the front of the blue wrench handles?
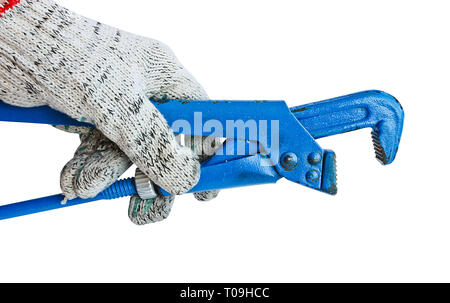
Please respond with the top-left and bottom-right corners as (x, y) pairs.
(97, 95), (200, 195)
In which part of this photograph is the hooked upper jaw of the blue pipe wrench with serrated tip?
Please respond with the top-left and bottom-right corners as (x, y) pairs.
(291, 90), (405, 169)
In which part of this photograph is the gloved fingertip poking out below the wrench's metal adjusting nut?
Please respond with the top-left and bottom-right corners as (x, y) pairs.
(128, 195), (175, 225)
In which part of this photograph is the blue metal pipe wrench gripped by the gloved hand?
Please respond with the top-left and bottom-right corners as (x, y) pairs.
(0, 90), (404, 220)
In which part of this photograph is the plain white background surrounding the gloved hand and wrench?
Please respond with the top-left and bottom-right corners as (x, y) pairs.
(0, 0), (450, 282)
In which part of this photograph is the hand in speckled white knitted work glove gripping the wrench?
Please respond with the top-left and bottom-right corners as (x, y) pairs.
(0, 0), (217, 224)
